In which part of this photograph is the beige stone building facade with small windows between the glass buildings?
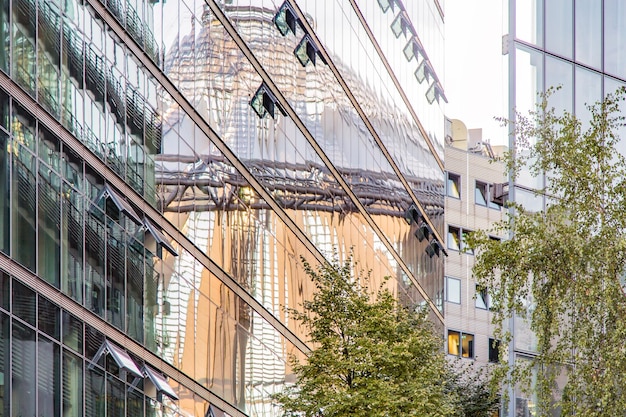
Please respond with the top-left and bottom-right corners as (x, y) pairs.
(445, 119), (506, 366)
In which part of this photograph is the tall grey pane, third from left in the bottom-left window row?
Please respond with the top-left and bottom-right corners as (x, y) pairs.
(37, 336), (61, 417)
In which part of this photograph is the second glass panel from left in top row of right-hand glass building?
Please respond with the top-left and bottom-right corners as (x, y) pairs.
(546, 0), (568, 58)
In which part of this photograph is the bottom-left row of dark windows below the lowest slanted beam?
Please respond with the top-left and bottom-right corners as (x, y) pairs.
(0, 271), (178, 417)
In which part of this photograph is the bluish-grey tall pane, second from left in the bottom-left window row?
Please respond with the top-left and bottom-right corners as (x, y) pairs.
(11, 320), (37, 417)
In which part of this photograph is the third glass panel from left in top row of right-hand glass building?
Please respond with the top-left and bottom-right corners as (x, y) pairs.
(575, 0), (602, 68)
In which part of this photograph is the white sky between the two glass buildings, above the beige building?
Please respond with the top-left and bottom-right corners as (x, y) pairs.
(443, 0), (508, 145)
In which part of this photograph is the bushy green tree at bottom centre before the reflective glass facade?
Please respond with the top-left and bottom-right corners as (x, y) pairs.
(274, 260), (498, 417)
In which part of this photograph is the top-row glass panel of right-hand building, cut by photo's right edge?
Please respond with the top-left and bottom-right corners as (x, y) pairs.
(604, 0), (626, 78)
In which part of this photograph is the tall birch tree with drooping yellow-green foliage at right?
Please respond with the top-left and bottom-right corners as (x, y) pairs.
(469, 91), (626, 416)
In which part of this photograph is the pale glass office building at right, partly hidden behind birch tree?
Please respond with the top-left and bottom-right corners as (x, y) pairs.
(503, 0), (626, 416)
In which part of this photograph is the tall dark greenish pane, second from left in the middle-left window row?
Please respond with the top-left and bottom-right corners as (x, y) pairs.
(11, 145), (37, 272)
